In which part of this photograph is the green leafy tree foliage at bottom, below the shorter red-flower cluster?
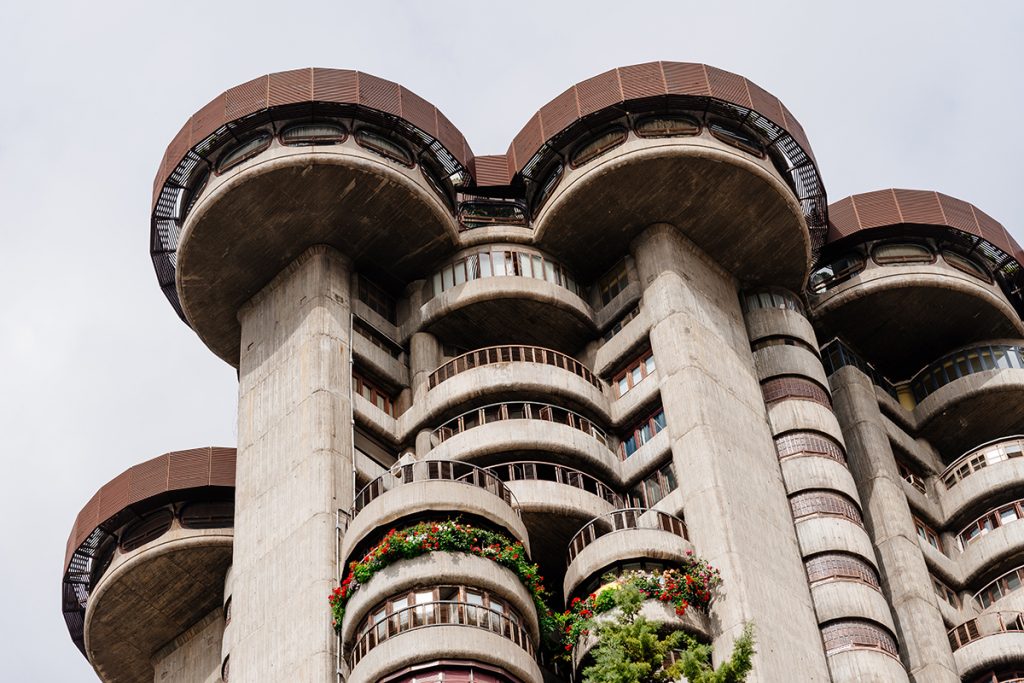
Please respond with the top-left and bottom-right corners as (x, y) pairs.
(583, 585), (754, 683)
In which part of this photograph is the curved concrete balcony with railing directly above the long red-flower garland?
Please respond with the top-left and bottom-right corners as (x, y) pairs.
(341, 460), (529, 569)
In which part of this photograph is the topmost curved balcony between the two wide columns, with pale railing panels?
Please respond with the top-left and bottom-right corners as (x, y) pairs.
(420, 245), (597, 350)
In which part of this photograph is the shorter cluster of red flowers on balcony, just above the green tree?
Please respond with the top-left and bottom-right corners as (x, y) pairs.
(557, 550), (722, 652)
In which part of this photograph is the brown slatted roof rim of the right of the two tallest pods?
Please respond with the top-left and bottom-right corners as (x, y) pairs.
(506, 61), (817, 174)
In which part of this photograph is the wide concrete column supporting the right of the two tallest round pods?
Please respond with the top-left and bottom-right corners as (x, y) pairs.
(632, 224), (829, 683)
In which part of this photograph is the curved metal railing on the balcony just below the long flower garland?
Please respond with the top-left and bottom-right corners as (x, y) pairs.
(350, 600), (535, 667)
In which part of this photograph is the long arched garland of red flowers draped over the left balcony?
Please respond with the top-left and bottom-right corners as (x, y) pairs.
(329, 519), (557, 632)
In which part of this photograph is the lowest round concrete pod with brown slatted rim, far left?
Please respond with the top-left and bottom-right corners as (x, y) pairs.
(61, 447), (234, 680)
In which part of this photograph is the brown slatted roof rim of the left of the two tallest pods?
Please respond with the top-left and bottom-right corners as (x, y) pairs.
(153, 67), (473, 208)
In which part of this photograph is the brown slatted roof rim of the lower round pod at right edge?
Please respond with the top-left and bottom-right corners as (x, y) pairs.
(826, 188), (1024, 263)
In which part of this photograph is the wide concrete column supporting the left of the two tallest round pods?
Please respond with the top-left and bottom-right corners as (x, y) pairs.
(227, 247), (352, 683)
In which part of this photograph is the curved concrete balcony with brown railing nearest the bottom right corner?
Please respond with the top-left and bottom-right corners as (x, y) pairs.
(947, 611), (1024, 677)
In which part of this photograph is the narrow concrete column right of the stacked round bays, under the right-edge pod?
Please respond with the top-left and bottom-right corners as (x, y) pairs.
(829, 367), (961, 683)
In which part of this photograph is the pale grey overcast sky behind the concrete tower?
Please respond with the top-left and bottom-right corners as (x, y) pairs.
(0, 0), (1024, 682)
